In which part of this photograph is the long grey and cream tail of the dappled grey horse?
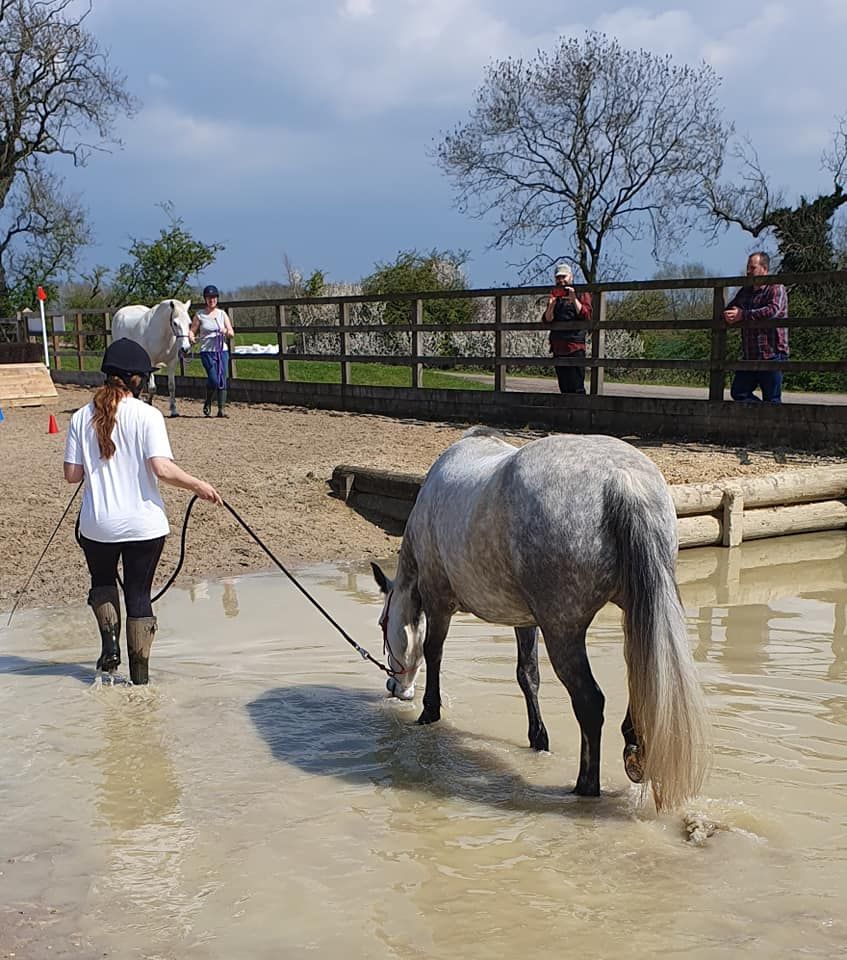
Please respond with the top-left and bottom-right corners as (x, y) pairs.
(604, 471), (709, 810)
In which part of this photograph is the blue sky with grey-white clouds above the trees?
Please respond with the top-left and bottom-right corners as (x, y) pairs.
(54, 0), (847, 290)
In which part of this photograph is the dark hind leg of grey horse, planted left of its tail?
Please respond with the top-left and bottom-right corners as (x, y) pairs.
(541, 624), (606, 797)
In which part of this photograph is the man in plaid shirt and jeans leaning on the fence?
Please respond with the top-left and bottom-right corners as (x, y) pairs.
(723, 251), (788, 403)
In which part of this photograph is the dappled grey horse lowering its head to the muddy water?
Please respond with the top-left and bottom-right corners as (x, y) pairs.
(373, 427), (708, 809)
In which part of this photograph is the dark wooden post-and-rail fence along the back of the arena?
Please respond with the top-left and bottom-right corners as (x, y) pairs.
(0, 271), (847, 402)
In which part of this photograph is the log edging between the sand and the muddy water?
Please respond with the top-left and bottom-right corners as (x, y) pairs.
(328, 464), (847, 549)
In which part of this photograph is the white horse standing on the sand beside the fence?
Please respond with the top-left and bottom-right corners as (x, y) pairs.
(112, 300), (191, 417)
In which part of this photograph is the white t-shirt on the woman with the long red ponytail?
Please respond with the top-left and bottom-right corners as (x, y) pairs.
(65, 397), (173, 543)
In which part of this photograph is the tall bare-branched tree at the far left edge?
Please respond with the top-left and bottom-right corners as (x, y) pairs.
(0, 0), (137, 312)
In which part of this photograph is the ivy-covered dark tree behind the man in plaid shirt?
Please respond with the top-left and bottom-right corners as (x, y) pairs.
(707, 118), (847, 390)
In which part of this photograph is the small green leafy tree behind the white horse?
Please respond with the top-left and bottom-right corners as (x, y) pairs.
(112, 203), (225, 305)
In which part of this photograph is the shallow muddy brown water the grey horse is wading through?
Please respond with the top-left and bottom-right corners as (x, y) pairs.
(0, 534), (847, 960)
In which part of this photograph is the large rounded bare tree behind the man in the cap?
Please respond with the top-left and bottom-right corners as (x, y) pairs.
(436, 32), (731, 281)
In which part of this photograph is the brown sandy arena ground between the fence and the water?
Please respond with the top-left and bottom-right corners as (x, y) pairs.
(0, 386), (837, 610)
